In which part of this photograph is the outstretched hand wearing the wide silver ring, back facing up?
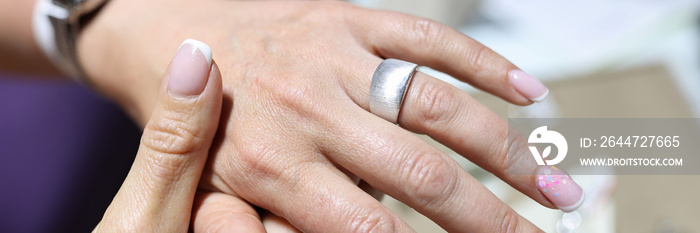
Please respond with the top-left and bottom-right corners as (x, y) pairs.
(79, 0), (582, 232)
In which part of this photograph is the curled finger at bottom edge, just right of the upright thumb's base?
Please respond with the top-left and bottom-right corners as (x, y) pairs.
(192, 192), (265, 233)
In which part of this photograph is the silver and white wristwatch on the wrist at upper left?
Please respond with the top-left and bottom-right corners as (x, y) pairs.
(33, 0), (107, 81)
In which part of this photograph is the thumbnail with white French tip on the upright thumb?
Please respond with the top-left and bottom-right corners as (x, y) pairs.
(168, 39), (211, 97)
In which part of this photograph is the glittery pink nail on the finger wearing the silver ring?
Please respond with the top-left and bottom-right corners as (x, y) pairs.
(535, 166), (586, 213)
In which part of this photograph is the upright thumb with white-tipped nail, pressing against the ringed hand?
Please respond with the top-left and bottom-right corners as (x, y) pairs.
(96, 40), (222, 232)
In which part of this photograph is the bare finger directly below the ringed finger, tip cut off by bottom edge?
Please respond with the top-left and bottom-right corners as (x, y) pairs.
(322, 109), (538, 232)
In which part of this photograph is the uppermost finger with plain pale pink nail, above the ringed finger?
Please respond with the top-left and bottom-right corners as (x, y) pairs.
(352, 10), (549, 105)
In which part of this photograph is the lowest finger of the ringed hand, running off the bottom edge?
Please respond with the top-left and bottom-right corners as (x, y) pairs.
(216, 145), (412, 232)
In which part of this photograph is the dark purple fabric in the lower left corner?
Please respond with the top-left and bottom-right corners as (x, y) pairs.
(0, 75), (140, 232)
